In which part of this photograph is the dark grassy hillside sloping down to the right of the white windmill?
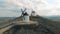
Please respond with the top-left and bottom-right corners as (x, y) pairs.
(31, 16), (60, 34)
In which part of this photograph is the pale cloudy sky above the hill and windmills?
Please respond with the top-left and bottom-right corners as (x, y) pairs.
(0, 0), (60, 17)
